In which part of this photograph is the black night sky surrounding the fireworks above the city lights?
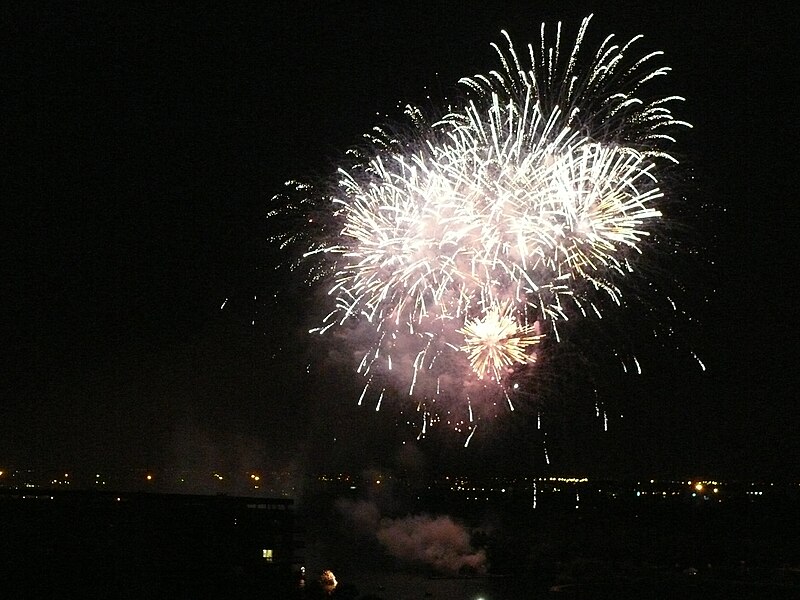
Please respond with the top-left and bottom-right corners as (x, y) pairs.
(0, 0), (800, 477)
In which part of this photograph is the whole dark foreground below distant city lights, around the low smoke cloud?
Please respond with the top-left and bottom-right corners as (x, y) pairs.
(0, 490), (800, 600)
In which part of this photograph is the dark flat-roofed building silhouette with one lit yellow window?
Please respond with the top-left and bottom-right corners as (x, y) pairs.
(0, 489), (295, 600)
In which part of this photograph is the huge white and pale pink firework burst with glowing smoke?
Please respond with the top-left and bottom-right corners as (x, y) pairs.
(278, 17), (688, 439)
